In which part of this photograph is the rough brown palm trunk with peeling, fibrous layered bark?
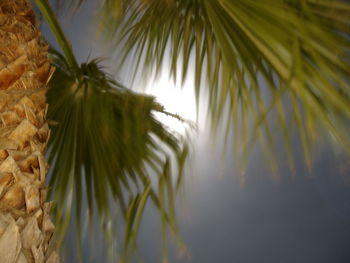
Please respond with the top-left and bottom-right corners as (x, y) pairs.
(0, 0), (58, 263)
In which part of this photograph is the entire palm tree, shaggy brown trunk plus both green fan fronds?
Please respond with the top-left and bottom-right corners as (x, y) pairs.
(0, 0), (350, 262)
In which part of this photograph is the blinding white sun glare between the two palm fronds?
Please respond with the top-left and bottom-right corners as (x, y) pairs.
(145, 74), (196, 135)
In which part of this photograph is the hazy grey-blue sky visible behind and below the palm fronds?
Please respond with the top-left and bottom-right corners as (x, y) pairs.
(39, 2), (350, 263)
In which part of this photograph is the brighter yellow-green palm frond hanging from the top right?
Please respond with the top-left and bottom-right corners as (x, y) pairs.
(98, 0), (350, 173)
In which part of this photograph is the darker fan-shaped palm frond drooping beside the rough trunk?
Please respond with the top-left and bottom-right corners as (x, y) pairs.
(47, 48), (188, 258)
